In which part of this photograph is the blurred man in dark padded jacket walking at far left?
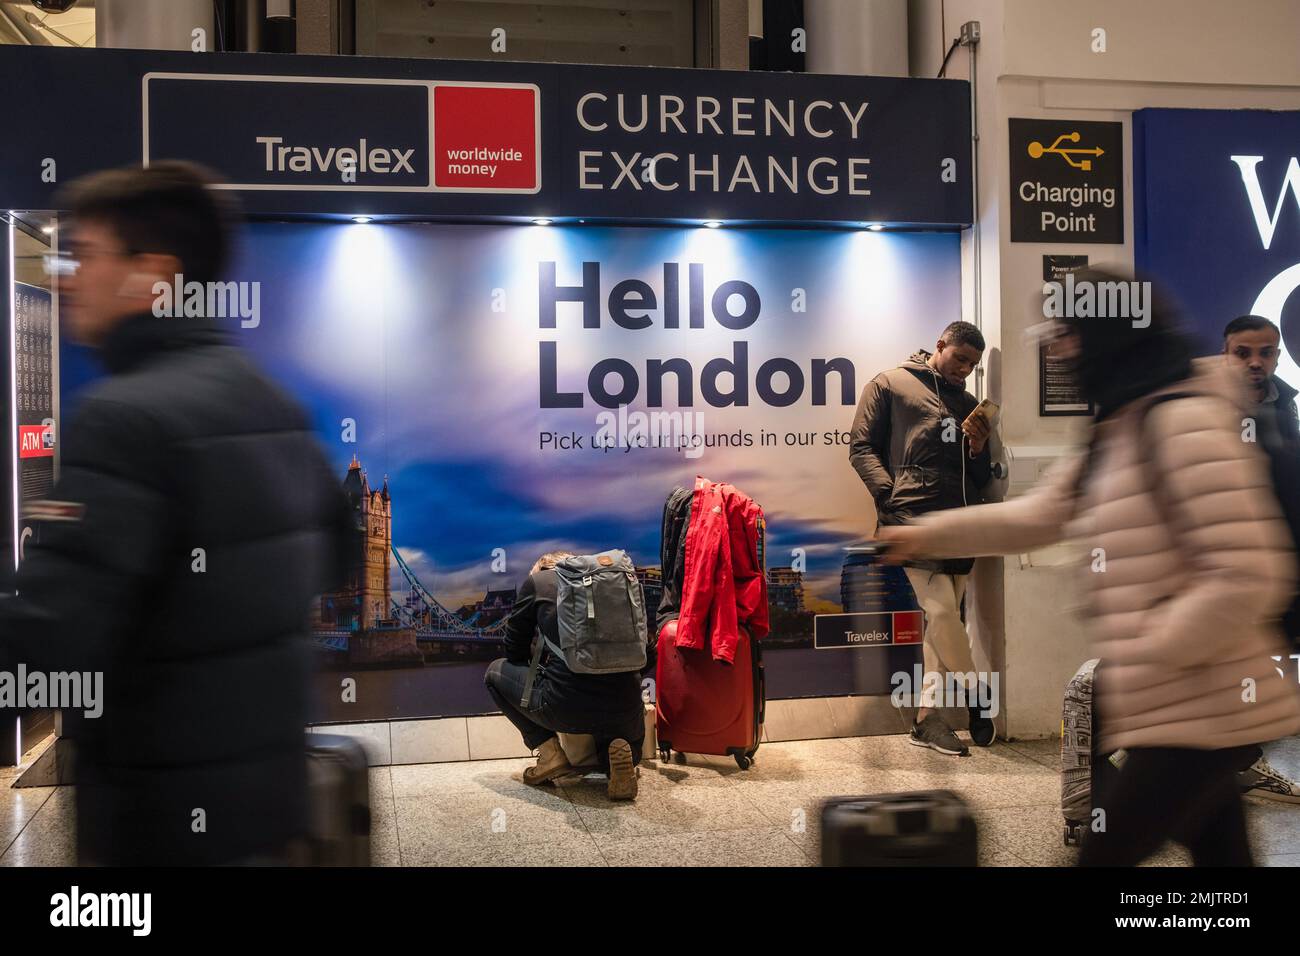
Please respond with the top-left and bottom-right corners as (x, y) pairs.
(0, 163), (347, 865)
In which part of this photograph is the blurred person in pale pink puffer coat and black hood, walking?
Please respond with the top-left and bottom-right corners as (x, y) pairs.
(881, 271), (1300, 865)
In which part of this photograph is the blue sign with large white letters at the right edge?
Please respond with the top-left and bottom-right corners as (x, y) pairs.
(1134, 109), (1300, 384)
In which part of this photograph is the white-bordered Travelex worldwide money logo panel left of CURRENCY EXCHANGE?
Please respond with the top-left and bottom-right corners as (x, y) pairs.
(143, 73), (542, 194)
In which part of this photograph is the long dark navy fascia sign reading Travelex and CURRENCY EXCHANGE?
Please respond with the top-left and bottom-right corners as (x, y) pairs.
(0, 47), (971, 229)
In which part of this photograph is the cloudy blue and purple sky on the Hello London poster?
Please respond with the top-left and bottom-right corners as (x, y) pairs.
(226, 224), (959, 607)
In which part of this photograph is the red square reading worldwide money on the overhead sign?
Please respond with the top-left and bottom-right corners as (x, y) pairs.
(433, 82), (542, 193)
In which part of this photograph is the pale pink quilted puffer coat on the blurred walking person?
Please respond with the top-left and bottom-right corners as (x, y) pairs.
(918, 358), (1300, 752)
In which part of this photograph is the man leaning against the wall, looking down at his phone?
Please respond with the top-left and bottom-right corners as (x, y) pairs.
(849, 321), (993, 754)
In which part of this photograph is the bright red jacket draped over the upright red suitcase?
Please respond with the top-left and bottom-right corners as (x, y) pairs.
(676, 476), (770, 663)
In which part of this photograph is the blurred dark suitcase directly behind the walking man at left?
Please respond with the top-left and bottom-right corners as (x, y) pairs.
(307, 734), (371, 866)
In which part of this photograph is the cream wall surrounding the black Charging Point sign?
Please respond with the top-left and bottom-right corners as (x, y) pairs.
(909, 0), (1300, 736)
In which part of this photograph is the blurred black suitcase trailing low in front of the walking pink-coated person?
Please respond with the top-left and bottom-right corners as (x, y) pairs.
(822, 790), (978, 866)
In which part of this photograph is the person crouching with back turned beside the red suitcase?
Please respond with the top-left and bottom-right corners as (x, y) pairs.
(484, 551), (655, 800)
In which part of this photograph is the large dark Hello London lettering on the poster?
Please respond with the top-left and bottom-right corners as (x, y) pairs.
(538, 261), (857, 408)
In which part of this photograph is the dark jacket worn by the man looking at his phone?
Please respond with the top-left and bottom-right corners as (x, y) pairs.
(849, 350), (992, 574)
